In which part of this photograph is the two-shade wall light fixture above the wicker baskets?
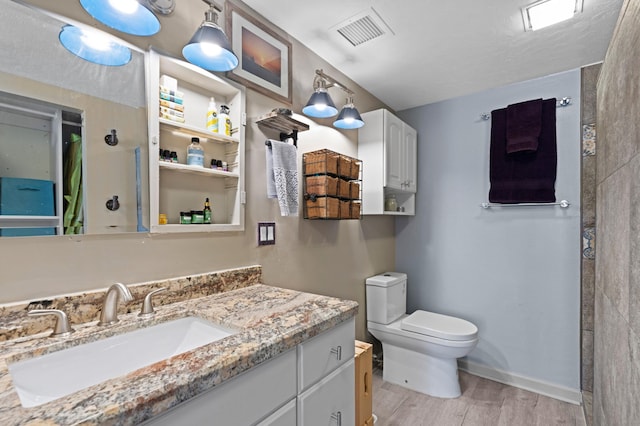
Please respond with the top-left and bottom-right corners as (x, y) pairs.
(302, 69), (364, 129)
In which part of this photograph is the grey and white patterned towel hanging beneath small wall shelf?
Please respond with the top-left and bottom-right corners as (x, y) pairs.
(266, 139), (298, 216)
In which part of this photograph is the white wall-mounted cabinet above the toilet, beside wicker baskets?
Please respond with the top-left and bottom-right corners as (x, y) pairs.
(358, 109), (418, 215)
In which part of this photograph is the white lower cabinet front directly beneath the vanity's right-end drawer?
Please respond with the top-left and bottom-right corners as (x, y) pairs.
(298, 358), (356, 426)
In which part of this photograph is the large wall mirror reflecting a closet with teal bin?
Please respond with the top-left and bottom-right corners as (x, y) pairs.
(0, 0), (149, 238)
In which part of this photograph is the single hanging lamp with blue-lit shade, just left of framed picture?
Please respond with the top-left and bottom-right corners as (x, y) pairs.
(182, 0), (238, 72)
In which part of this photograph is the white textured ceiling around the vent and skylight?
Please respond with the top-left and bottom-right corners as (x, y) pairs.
(244, 0), (622, 110)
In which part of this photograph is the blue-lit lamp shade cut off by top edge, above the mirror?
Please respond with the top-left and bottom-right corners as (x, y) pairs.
(80, 0), (160, 36)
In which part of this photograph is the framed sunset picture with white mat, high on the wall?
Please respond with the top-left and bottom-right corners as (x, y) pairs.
(225, 2), (291, 104)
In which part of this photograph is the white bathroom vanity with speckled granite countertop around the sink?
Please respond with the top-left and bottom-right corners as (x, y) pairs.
(0, 284), (358, 425)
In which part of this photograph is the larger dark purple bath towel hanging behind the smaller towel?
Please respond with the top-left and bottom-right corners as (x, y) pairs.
(489, 98), (557, 203)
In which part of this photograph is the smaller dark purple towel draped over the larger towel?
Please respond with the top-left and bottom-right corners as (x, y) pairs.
(507, 99), (542, 154)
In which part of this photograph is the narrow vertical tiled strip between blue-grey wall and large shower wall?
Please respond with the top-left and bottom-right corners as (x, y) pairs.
(580, 64), (601, 424)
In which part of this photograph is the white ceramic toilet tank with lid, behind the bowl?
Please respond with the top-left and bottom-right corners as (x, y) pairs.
(366, 272), (407, 324)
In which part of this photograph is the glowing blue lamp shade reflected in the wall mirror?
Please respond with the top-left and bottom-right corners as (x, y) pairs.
(58, 25), (131, 66)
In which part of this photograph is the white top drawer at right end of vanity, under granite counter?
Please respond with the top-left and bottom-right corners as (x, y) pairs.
(298, 318), (355, 392)
